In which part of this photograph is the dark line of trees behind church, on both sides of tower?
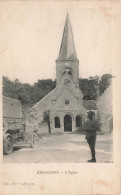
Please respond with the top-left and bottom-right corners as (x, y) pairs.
(3, 74), (112, 109)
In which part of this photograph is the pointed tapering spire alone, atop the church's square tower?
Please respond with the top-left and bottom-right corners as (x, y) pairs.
(57, 13), (77, 60)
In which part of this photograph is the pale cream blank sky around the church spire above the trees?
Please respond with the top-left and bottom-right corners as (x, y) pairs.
(0, 1), (118, 84)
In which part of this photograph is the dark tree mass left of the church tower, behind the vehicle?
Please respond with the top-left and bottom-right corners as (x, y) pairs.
(3, 77), (56, 109)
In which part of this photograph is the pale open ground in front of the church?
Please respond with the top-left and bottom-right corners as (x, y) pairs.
(3, 133), (113, 163)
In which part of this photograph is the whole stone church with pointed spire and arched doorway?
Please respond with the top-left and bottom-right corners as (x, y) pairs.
(29, 14), (96, 133)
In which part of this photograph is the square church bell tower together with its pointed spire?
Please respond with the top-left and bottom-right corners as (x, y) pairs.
(56, 14), (79, 86)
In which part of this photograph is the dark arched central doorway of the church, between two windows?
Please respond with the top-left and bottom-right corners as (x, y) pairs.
(64, 114), (72, 131)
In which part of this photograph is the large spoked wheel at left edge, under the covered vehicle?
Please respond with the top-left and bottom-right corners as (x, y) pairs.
(3, 136), (13, 155)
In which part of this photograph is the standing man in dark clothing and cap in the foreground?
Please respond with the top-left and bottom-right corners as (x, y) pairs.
(84, 111), (98, 162)
